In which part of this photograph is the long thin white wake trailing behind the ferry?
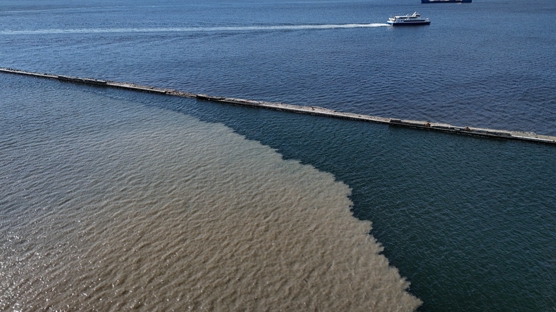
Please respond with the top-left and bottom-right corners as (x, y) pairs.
(0, 23), (388, 35)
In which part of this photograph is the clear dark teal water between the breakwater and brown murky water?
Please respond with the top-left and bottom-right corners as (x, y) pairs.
(193, 90), (556, 311)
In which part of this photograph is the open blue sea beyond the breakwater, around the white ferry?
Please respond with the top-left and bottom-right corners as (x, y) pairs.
(0, 0), (556, 135)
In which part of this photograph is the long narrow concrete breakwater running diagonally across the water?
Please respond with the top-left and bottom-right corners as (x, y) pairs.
(0, 68), (556, 145)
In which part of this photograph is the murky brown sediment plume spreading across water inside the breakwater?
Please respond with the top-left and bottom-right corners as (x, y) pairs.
(0, 78), (420, 311)
